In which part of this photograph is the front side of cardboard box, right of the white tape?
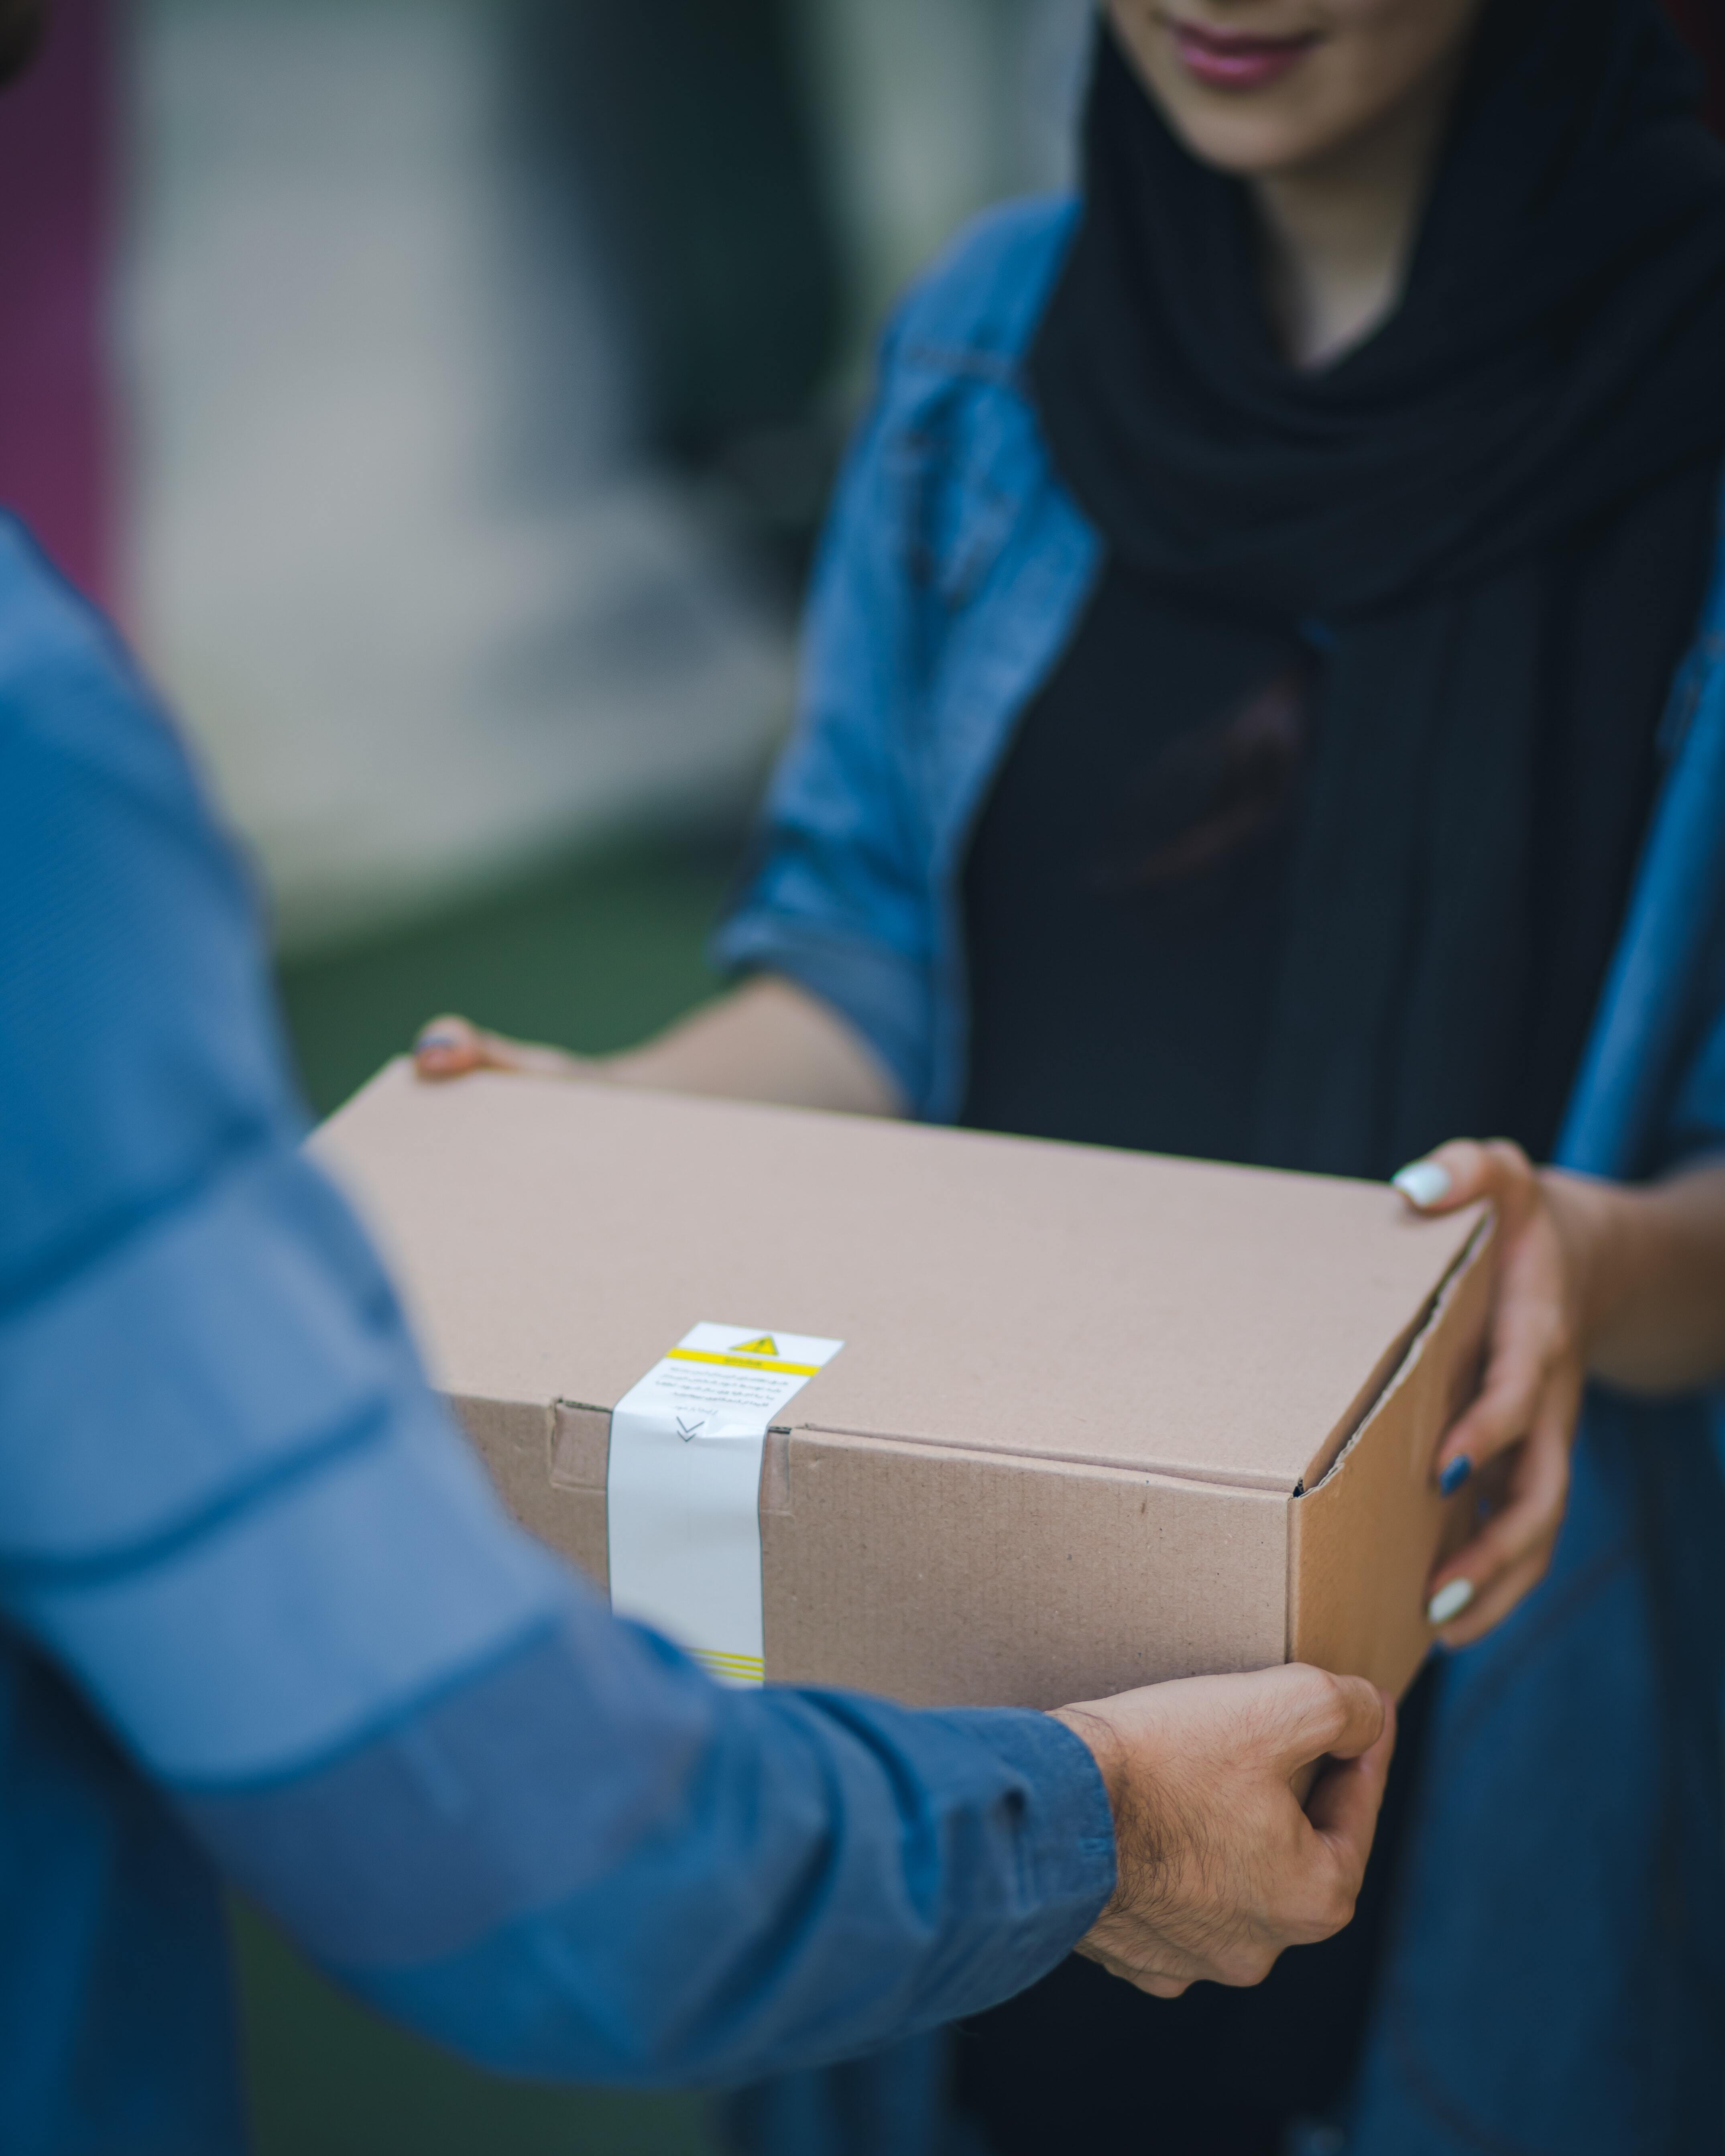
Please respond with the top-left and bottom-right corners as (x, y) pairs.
(763, 1432), (1287, 1708)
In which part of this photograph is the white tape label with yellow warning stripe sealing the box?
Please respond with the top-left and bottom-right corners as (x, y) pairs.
(606, 1324), (845, 1684)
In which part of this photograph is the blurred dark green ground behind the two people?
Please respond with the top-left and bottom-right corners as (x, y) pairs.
(251, 832), (735, 2156)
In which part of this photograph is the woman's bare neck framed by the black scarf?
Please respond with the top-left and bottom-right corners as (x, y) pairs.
(1249, 69), (1460, 371)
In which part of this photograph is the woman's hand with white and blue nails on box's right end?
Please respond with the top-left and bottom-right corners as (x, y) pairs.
(1395, 1141), (1604, 1647)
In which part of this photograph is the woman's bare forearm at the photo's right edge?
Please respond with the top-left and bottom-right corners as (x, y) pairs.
(1544, 1160), (1725, 1393)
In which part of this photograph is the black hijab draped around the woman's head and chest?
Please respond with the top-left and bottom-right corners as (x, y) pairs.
(1031, 0), (1725, 1175)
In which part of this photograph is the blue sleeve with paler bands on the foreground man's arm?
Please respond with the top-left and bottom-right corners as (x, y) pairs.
(0, 528), (1113, 2081)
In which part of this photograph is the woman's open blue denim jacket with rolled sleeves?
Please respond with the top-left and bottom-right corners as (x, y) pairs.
(716, 201), (1725, 2156)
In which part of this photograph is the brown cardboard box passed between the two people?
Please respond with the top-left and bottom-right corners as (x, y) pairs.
(315, 1065), (1490, 1708)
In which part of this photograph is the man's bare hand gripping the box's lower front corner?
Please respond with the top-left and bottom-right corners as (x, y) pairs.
(1054, 1662), (1395, 1999)
